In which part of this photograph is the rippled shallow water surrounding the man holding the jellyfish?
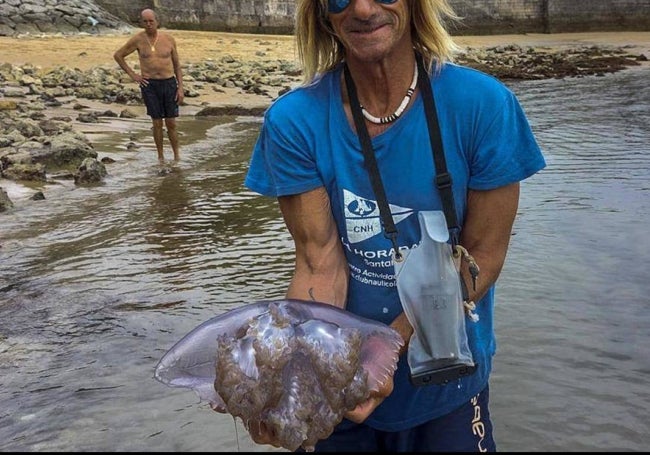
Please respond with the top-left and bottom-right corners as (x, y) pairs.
(0, 67), (650, 451)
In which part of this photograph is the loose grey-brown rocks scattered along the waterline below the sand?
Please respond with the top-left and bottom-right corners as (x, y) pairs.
(0, 45), (647, 212)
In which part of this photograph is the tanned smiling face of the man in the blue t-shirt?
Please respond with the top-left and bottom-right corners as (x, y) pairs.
(327, 0), (408, 61)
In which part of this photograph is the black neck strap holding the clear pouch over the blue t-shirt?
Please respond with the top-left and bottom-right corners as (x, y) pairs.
(343, 54), (460, 255)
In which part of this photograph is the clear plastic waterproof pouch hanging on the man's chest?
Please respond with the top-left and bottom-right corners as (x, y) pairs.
(395, 211), (476, 385)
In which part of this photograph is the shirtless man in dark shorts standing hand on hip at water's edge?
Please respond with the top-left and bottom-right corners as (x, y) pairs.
(113, 9), (183, 162)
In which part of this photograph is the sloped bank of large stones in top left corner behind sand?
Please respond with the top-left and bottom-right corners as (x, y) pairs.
(0, 0), (133, 36)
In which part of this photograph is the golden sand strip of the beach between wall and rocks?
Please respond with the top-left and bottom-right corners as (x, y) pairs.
(0, 29), (650, 110)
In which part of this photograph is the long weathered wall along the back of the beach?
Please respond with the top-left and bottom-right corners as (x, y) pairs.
(96, 0), (650, 35)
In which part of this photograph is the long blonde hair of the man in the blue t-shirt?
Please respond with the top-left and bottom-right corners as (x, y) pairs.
(295, 0), (459, 83)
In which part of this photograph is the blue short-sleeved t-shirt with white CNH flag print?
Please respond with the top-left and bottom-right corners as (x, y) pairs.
(245, 64), (545, 431)
